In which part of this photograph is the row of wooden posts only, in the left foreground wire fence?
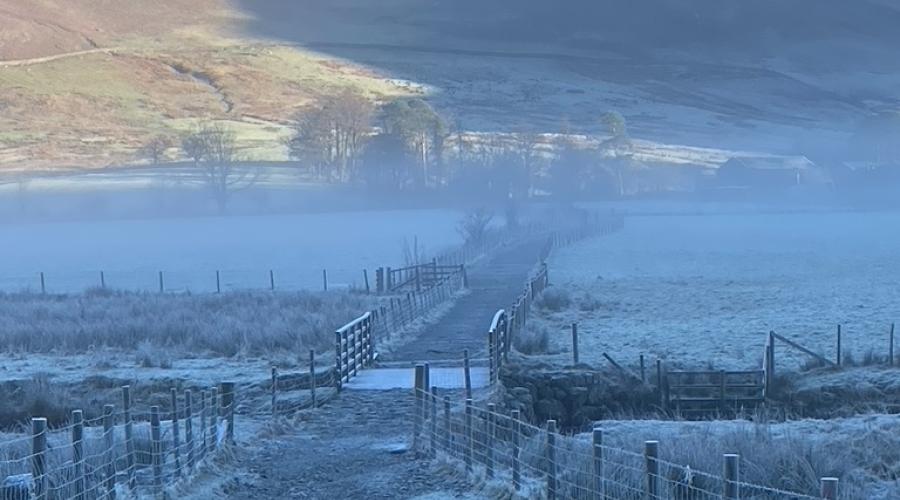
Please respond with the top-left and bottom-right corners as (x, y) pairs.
(29, 382), (235, 500)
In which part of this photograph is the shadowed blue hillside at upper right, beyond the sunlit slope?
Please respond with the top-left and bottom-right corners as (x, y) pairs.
(240, 0), (900, 153)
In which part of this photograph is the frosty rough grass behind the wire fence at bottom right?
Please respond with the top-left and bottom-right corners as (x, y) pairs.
(582, 415), (900, 499)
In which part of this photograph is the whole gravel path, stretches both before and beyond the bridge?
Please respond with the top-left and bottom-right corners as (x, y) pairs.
(224, 238), (544, 500)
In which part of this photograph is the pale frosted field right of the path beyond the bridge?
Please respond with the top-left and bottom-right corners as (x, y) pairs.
(538, 213), (900, 369)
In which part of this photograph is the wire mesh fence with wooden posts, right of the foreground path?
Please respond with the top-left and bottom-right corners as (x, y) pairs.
(411, 384), (838, 500)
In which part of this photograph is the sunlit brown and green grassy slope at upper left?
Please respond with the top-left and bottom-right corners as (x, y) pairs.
(0, 0), (414, 169)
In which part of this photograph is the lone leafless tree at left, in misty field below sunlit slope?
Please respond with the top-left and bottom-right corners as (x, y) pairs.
(182, 123), (260, 213)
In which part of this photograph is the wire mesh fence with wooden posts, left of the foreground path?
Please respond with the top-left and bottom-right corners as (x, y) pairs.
(0, 383), (236, 500)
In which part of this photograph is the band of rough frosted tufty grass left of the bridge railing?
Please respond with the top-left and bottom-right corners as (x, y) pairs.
(0, 291), (371, 358)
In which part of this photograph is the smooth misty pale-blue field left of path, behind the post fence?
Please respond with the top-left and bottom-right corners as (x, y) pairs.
(0, 210), (460, 292)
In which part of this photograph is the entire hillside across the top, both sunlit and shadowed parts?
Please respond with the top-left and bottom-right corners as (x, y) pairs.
(0, 0), (900, 170)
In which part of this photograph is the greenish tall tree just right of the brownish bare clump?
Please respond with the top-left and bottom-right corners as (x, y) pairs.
(381, 99), (447, 186)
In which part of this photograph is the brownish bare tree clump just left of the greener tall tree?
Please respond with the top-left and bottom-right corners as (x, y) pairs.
(288, 90), (374, 182)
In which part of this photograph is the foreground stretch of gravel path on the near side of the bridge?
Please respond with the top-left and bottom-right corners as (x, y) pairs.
(225, 390), (469, 499)
